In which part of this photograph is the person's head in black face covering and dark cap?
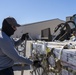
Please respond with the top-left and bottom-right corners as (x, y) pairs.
(2, 17), (20, 36)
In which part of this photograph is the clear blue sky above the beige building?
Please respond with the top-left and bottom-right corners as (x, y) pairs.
(0, 0), (76, 28)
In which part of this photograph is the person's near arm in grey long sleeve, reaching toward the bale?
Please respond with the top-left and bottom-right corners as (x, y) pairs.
(0, 39), (32, 65)
